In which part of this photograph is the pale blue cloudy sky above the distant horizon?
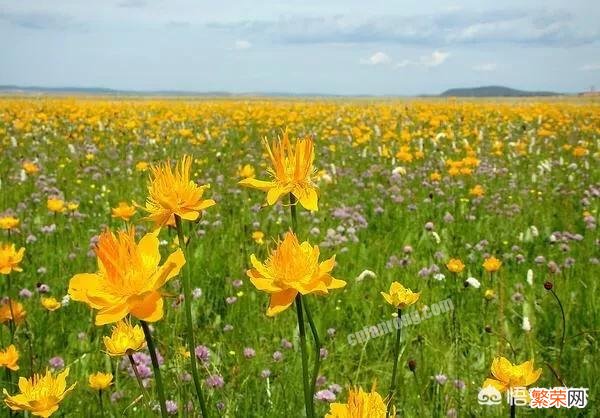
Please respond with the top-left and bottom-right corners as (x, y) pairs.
(0, 0), (600, 95)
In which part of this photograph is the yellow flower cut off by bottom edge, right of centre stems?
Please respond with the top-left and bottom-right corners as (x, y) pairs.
(325, 388), (396, 418)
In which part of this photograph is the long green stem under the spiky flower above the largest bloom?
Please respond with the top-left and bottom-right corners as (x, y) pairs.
(175, 215), (208, 418)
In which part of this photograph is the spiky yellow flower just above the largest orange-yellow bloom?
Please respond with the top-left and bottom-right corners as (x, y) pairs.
(146, 155), (215, 227)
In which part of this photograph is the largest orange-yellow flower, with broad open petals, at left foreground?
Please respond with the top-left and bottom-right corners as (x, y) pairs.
(69, 228), (185, 325)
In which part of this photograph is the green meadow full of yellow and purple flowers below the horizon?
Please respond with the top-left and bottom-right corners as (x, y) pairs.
(0, 97), (600, 417)
